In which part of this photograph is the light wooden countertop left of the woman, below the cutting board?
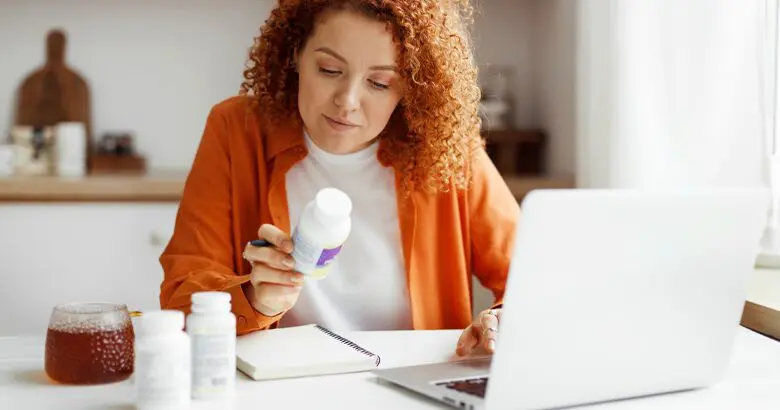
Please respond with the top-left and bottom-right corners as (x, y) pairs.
(0, 171), (187, 202)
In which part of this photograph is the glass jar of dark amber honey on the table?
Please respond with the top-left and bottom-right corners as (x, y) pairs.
(45, 303), (135, 384)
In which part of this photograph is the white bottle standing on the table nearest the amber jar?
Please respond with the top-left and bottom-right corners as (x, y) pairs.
(134, 310), (191, 410)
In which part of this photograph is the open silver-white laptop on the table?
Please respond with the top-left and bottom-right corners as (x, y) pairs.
(373, 188), (769, 410)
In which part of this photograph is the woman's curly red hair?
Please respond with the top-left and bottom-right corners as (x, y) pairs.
(241, 0), (484, 192)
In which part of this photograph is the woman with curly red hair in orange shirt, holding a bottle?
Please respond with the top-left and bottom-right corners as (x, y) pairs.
(160, 0), (519, 355)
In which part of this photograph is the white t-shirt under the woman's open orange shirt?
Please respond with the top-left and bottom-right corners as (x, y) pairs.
(280, 135), (412, 331)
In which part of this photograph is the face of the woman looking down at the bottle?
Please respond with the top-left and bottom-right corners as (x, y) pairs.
(296, 11), (403, 154)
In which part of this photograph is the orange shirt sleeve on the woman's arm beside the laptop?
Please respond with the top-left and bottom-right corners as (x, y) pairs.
(468, 150), (520, 307)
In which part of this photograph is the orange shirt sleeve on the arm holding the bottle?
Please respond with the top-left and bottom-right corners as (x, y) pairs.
(160, 106), (279, 334)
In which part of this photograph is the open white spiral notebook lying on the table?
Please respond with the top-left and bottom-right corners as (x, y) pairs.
(236, 325), (380, 380)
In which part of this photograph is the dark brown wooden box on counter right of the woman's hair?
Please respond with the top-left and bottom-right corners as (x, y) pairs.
(482, 129), (547, 175)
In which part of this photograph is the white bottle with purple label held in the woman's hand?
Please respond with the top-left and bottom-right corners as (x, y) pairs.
(292, 188), (352, 279)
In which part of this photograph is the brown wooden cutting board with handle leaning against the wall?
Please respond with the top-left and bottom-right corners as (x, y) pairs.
(14, 30), (93, 165)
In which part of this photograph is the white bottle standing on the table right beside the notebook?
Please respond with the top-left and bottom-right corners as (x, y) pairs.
(187, 292), (236, 401)
